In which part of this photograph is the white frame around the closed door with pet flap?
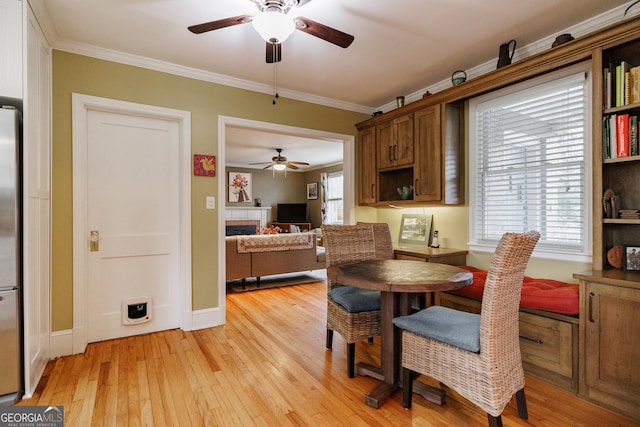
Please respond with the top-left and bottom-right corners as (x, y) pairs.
(72, 93), (192, 354)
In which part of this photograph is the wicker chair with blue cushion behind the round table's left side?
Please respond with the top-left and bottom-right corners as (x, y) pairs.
(321, 223), (393, 378)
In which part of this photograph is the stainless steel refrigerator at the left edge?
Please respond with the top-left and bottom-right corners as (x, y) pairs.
(0, 106), (24, 405)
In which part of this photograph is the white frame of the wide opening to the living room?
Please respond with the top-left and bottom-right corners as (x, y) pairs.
(218, 116), (355, 324)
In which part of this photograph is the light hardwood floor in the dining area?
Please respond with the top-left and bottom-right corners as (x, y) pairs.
(20, 282), (640, 427)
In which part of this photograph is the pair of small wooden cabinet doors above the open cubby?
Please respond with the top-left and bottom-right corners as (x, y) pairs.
(376, 114), (413, 169)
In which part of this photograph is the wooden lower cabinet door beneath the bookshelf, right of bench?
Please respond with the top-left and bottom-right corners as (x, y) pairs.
(581, 283), (640, 418)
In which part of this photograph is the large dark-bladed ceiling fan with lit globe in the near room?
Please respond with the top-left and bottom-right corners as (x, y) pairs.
(188, 0), (354, 64)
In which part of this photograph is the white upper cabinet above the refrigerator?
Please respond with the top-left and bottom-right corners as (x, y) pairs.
(0, 0), (22, 99)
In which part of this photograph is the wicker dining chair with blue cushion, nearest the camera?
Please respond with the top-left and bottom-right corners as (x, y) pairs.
(393, 231), (540, 426)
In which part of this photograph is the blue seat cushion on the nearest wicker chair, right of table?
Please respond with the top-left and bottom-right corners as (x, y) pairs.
(393, 306), (480, 353)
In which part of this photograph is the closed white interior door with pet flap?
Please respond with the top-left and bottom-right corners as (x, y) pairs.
(86, 110), (180, 342)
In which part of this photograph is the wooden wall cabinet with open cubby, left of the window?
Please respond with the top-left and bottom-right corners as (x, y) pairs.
(358, 102), (464, 206)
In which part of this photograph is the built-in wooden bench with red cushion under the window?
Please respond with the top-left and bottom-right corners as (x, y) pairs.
(434, 266), (579, 392)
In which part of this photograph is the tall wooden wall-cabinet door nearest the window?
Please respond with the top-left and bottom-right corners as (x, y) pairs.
(413, 105), (442, 202)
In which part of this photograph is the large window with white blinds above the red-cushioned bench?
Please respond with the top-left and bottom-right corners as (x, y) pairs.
(469, 69), (591, 258)
